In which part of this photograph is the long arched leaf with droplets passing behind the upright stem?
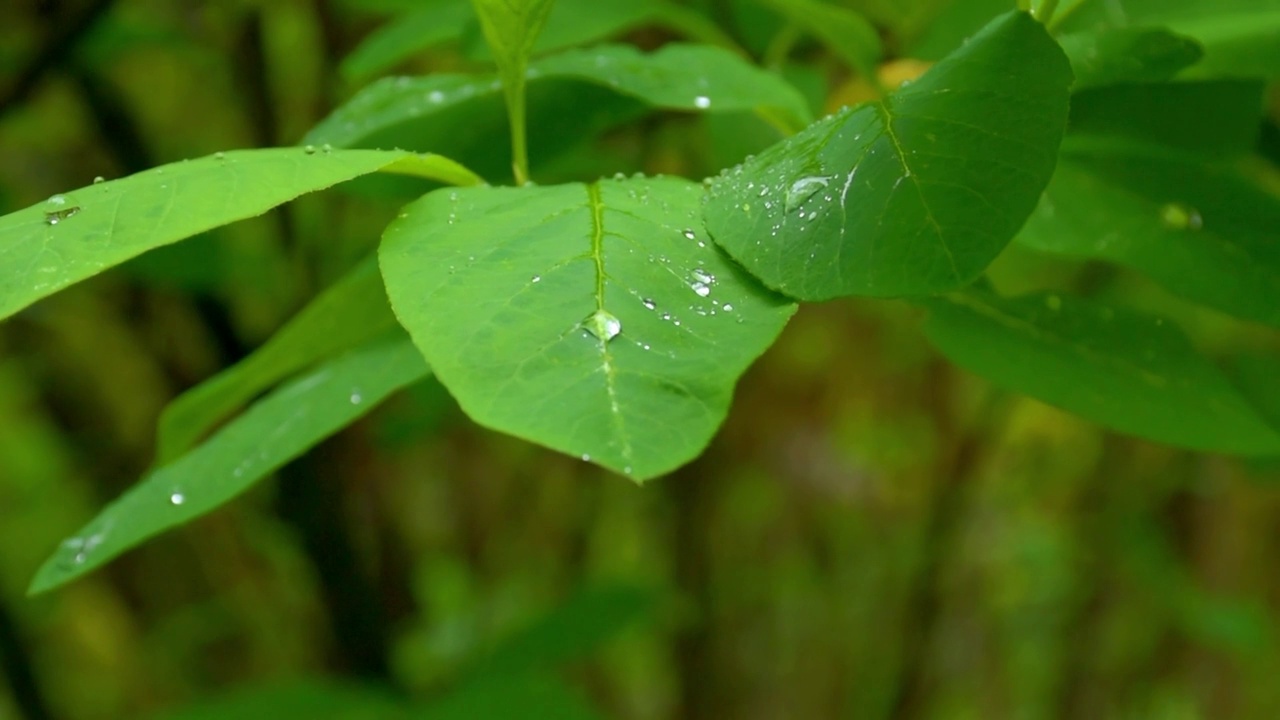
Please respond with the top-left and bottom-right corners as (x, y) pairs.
(307, 44), (810, 152)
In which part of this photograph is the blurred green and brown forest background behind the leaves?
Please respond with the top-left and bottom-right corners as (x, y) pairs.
(0, 0), (1280, 720)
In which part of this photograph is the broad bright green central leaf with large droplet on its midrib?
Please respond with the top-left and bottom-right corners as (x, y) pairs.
(380, 178), (795, 480)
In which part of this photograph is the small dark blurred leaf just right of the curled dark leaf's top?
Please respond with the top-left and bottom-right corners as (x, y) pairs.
(1059, 27), (1204, 90)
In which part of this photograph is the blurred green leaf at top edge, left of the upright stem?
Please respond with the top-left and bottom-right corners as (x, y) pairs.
(339, 0), (472, 81)
